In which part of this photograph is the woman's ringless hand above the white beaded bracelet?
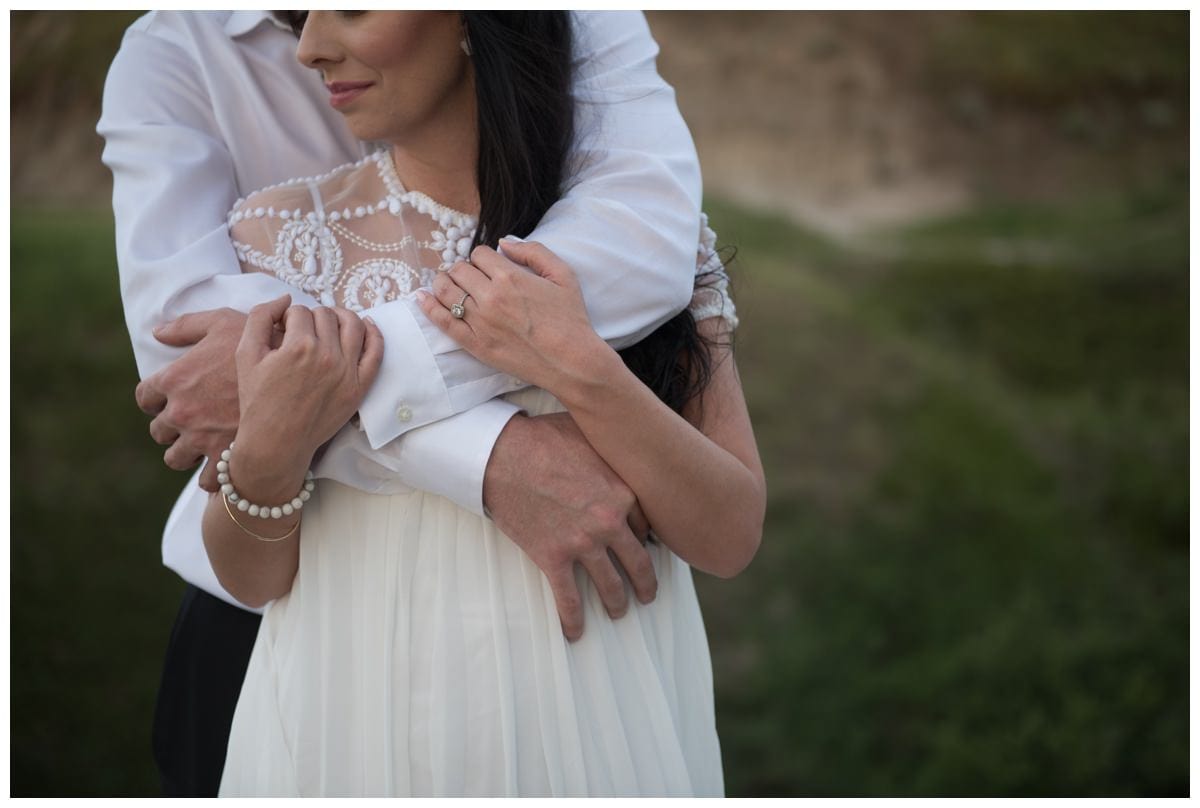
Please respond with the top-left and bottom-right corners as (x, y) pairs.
(234, 295), (383, 492)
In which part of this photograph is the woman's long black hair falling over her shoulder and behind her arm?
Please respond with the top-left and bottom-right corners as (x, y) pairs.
(276, 11), (712, 412)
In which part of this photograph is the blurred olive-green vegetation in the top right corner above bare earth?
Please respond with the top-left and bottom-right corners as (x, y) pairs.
(924, 11), (1189, 148)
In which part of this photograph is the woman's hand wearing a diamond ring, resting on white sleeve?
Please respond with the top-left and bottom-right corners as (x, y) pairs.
(418, 240), (606, 393)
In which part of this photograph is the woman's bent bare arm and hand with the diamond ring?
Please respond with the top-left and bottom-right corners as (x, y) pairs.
(421, 236), (766, 576)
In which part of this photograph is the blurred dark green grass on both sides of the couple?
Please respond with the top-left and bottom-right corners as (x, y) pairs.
(11, 180), (1188, 795)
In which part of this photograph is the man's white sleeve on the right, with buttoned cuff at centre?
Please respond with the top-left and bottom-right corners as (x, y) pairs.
(359, 12), (701, 447)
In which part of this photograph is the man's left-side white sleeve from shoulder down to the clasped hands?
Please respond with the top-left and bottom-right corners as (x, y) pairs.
(97, 30), (313, 378)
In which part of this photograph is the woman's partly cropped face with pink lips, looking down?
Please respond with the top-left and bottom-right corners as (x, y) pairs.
(296, 11), (474, 143)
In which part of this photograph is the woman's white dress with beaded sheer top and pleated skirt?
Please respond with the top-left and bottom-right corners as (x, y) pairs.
(221, 152), (736, 796)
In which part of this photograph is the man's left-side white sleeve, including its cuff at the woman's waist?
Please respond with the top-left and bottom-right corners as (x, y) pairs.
(97, 30), (517, 513)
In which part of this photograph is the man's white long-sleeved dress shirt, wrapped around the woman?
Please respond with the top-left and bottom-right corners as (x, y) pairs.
(97, 12), (701, 605)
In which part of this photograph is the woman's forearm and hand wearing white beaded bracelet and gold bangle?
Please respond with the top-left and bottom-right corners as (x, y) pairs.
(202, 295), (383, 608)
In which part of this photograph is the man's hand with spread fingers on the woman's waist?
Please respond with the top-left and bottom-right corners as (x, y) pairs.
(484, 413), (658, 640)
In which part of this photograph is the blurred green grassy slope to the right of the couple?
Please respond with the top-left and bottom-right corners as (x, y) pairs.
(702, 166), (1189, 796)
